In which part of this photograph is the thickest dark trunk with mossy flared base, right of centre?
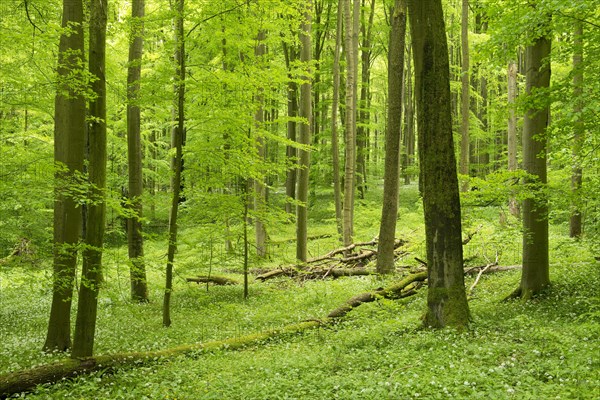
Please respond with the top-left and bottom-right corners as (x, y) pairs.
(409, 0), (470, 327)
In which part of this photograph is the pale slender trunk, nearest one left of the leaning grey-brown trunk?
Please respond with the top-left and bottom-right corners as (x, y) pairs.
(342, 0), (360, 246)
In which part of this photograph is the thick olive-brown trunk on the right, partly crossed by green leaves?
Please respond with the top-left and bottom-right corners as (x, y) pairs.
(515, 19), (551, 299)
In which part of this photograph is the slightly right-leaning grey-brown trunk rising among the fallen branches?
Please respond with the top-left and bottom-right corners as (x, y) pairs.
(377, 0), (406, 274)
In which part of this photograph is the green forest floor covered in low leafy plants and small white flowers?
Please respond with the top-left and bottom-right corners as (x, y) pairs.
(0, 185), (600, 399)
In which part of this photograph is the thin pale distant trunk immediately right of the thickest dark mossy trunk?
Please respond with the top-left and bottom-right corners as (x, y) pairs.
(460, 0), (471, 192)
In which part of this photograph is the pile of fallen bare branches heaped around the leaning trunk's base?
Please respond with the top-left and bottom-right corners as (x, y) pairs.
(256, 239), (407, 282)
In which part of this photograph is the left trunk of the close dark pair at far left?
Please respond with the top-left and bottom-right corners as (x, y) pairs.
(44, 0), (85, 351)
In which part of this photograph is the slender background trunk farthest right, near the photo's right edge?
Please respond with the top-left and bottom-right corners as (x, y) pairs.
(569, 20), (584, 237)
